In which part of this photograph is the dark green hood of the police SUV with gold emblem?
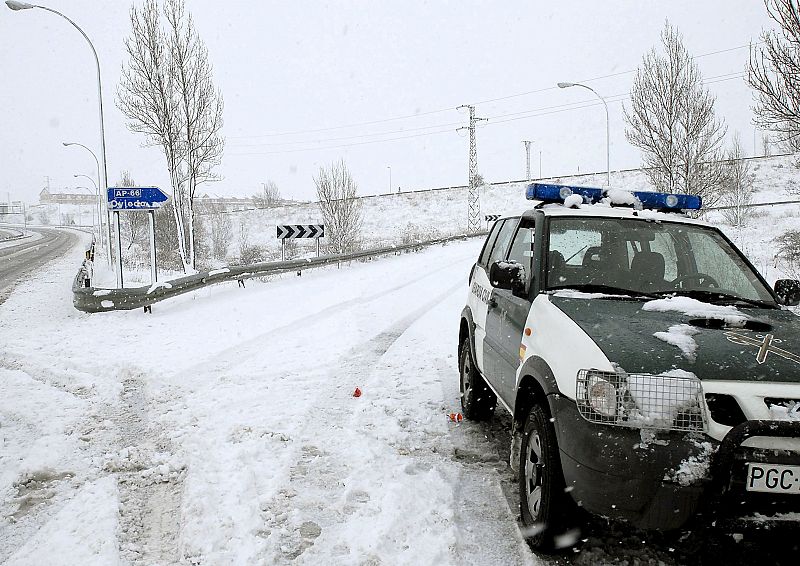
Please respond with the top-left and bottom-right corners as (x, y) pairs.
(550, 295), (800, 383)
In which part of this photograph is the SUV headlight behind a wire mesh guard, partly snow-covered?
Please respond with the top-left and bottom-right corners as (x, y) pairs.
(575, 370), (706, 431)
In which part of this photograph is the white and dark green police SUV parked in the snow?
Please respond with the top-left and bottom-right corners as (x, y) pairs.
(458, 183), (800, 549)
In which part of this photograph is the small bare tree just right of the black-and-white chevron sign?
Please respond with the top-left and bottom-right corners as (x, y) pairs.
(314, 160), (362, 254)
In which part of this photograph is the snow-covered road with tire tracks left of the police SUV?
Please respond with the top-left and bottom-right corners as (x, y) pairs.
(0, 233), (539, 565)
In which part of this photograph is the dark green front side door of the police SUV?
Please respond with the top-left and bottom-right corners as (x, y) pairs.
(484, 219), (534, 405)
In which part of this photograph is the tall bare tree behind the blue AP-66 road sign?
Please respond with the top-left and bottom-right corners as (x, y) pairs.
(117, 0), (224, 270)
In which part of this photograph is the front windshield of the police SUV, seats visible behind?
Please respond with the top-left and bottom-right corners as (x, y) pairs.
(546, 217), (776, 306)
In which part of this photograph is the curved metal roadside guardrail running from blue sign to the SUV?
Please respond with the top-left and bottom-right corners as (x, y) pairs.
(72, 232), (486, 313)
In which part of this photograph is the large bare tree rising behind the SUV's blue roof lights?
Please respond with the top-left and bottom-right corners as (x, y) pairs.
(625, 22), (727, 204)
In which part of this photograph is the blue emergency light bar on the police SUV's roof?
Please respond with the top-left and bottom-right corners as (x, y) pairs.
(525, 183), (703, 210)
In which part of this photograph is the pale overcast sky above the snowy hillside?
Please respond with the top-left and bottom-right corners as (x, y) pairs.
(0, 0), (773, 202)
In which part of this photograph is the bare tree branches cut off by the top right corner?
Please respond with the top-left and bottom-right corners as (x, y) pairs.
(747, 0), (800, 152)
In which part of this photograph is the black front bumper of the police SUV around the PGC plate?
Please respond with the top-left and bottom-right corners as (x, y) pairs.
(549, 395), (800, 530)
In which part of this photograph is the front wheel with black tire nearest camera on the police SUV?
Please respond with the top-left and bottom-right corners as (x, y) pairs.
(519, 404), (577, 552)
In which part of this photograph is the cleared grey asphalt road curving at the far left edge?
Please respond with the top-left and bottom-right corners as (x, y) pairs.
(0, 228), (78, 303)
